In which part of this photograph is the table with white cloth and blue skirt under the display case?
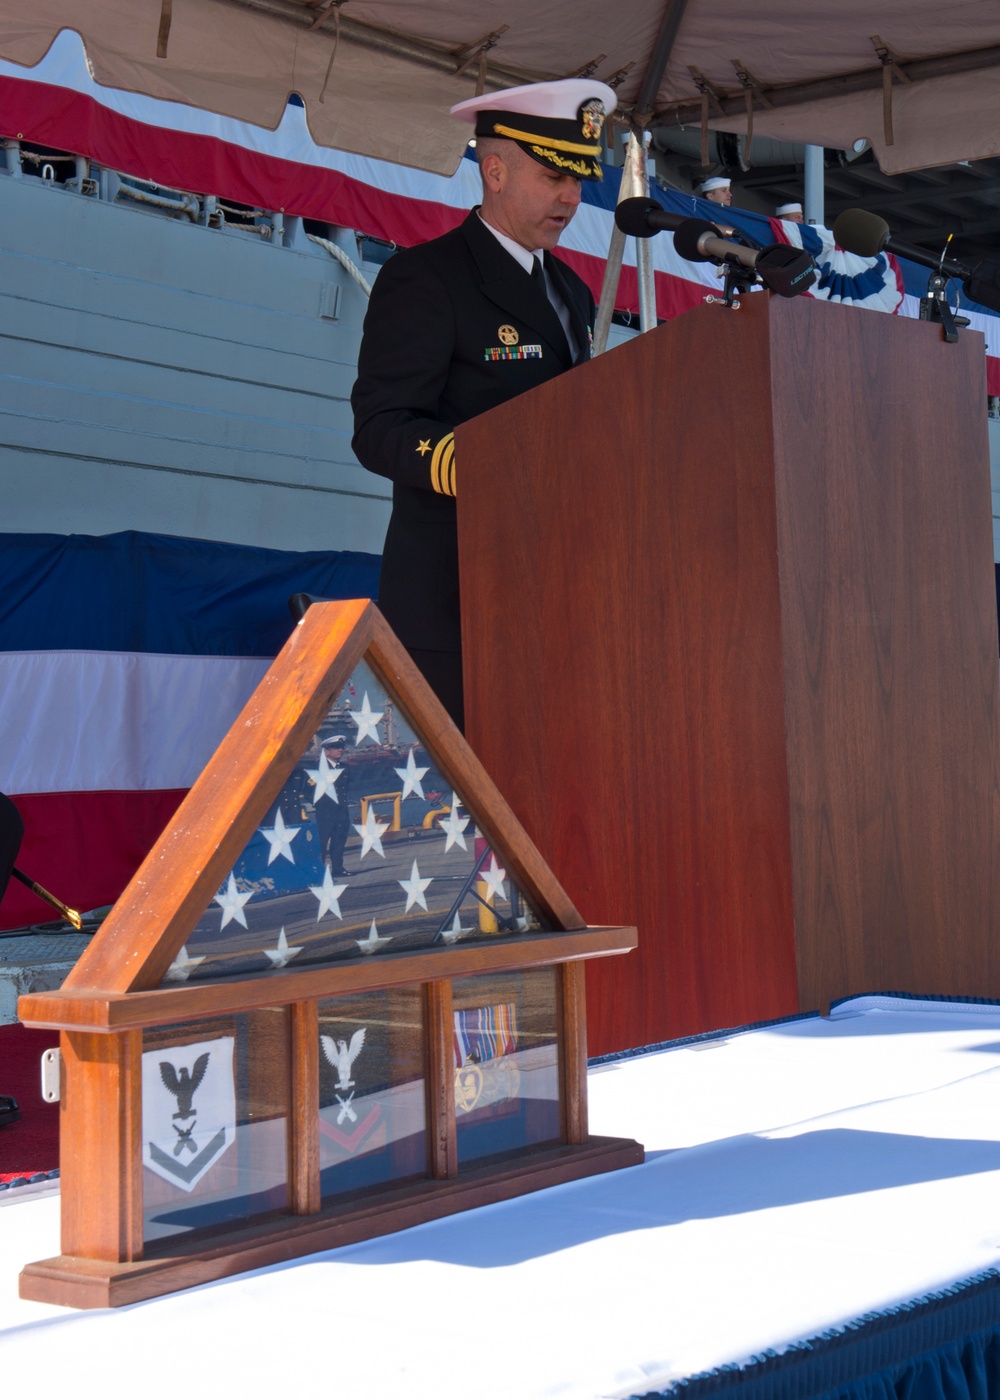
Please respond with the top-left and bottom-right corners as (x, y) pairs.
(0, 997), (1000, 1400)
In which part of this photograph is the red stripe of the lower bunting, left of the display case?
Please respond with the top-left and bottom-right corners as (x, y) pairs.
(0, 790), (186, 928)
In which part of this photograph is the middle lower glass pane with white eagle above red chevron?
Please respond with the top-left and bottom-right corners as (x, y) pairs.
(319, 987), (427, 1200)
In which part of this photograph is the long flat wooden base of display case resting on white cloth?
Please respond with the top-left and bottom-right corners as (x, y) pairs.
(20, 1137), (644, 1308)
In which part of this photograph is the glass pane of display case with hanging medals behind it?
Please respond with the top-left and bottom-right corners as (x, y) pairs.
(451, 967), (563, 1166)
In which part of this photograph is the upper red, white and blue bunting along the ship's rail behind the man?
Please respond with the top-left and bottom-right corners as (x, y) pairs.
(7, 29), (1000, 393)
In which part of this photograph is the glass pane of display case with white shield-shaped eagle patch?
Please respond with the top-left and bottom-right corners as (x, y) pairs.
(143, 1007), (290, 1246)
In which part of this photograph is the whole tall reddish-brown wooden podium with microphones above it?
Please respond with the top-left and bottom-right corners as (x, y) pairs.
(457, 294), (1000, 1053)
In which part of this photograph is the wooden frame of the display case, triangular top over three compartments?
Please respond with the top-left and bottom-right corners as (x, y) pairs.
(18, 599), (641, 1306)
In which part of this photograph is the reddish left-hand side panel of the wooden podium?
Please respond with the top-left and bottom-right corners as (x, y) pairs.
(457, 298), (797, 1053)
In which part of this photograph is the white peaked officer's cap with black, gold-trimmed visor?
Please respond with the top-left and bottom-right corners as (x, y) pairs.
(451, 78), (618, 179)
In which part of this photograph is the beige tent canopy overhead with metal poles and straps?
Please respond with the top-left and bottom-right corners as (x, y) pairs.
(0, 0), (1000, 174)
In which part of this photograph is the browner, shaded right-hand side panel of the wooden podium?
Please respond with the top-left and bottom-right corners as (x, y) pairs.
(770, 302), (1000, 1008)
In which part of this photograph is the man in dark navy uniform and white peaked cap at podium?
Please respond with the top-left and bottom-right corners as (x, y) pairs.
(352, 78), (615, 728)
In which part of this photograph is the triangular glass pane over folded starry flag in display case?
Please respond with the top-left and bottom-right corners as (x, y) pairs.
(164, 661), (542, 986)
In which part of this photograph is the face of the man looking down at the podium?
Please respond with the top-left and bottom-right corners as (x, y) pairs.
(483, 141), (580, 252)
